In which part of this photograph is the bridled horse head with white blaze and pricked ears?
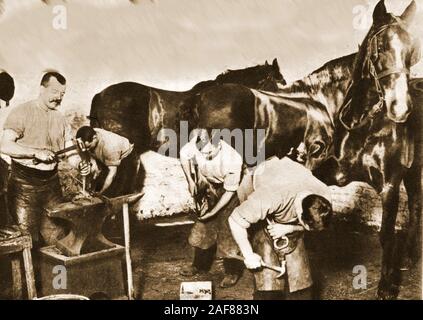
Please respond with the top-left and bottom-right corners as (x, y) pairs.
(340, 0), (421, 130)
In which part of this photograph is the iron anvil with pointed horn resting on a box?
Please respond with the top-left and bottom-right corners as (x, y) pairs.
(45, 193), (143, 256)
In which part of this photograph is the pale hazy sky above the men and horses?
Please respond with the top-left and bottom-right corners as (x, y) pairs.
(0, 0), (423, 110)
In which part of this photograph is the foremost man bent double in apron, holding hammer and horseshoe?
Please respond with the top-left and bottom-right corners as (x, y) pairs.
(228, 157), (332, 300)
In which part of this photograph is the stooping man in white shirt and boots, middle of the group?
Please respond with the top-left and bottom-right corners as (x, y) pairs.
(180, 130), (243, 288)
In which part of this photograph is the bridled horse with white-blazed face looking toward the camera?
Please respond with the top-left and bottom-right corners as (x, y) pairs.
(280, 1), (422, 299)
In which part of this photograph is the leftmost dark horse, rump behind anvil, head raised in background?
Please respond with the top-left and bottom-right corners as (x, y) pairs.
(90, 59), (286, 190)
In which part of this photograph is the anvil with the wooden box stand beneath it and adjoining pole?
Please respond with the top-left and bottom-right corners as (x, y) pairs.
(40, 194), (142, 299)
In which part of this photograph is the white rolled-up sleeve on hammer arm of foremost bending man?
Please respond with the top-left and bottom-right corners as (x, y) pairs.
(231, 188), (281, 228)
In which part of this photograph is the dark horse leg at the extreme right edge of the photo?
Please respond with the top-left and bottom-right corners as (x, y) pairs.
(403, 165), (422, 270)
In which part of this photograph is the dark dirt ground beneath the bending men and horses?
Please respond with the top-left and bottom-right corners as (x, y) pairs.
(127, 223), (422, 300)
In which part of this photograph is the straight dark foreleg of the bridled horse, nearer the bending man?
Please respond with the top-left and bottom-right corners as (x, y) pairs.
(377, 175), (402, 300)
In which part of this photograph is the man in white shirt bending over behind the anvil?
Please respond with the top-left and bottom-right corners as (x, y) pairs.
(76, 126), (137, 197)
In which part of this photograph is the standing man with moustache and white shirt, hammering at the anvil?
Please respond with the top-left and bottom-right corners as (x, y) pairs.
(0, 72), (72, 245)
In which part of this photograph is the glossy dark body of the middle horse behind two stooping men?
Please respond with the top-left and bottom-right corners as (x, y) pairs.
(190, 84), (334, 170)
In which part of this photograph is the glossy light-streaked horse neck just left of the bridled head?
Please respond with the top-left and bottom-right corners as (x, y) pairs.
(278, 54), (356, 123)
